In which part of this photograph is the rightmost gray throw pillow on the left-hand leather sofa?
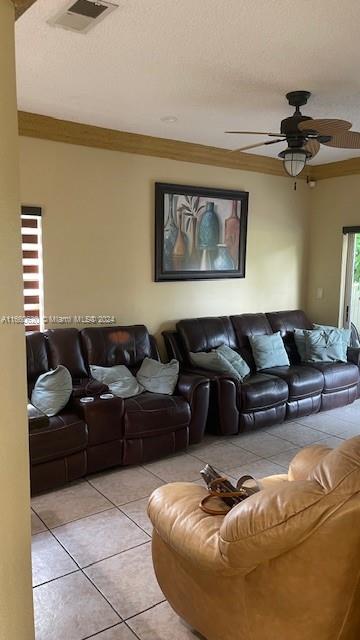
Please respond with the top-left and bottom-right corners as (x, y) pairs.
(136, 358), (179, 396)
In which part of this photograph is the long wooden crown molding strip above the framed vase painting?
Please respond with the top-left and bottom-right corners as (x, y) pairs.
(18, 111), (292, 177)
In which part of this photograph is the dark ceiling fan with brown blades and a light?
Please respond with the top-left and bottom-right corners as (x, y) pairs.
(225, 91), (360, 177)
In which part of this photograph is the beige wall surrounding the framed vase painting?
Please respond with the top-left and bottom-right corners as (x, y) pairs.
(20, 138), (309, 344)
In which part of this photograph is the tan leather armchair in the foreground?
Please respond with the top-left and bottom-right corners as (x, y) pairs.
(148, 437), (360, 640)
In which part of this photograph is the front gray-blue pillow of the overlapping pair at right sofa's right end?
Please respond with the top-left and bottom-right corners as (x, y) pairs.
(304, 329), (347, 362)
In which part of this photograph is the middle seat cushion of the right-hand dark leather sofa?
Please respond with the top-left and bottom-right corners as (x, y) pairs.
(264, 365), (324, 400)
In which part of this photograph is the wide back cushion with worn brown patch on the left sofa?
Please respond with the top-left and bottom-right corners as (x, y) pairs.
(81, 324), (158, 371)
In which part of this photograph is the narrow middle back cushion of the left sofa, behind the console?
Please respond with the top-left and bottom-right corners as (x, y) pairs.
(45, 328), (89, 379)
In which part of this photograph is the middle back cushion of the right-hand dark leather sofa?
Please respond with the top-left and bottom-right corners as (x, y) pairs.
(230, 313), (273, 370)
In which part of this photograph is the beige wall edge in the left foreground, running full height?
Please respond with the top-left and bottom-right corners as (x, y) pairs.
(0, 0), (34, 640)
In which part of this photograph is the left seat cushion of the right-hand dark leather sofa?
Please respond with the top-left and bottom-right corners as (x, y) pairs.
(239, 373), (289, 411)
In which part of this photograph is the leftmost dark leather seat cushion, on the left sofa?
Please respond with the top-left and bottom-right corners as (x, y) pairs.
(29, 412), (87, 464)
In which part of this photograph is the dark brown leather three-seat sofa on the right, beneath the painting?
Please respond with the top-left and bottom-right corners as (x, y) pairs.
(163, 310), (360, 435)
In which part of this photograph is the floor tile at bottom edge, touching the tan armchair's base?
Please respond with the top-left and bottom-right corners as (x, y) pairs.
(128, 602), (199, 640)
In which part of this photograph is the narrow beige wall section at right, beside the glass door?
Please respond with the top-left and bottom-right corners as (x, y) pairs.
(307, 176), (360, 324)
